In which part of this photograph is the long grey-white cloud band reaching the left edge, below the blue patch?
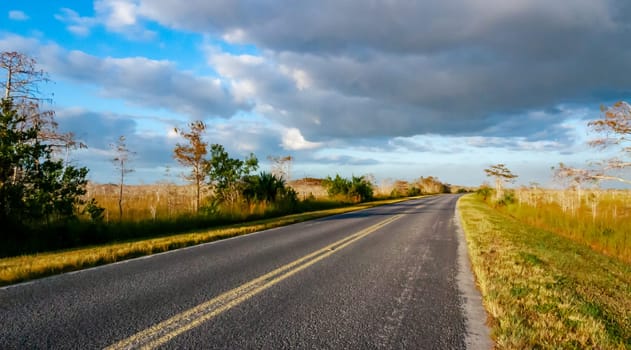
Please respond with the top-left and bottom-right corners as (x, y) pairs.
(0, 36), (251, 119)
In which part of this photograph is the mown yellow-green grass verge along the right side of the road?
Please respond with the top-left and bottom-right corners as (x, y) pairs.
(458, 195), (631, 349)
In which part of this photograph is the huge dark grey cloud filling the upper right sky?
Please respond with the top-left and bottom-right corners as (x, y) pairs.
(132, 0), (631, 140)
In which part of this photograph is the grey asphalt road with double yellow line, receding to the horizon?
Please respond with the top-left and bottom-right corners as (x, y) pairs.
(0, 195), (491, 349)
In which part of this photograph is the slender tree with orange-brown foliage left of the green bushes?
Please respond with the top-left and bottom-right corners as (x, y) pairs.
(173, 120), (208, 213)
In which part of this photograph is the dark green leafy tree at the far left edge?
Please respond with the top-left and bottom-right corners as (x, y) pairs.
(0, 99), (88, 237)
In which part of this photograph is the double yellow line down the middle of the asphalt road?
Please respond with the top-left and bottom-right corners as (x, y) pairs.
(106, 215), (402, 350)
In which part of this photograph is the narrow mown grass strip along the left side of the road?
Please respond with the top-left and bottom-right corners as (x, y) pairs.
(0, 199), (405, 285)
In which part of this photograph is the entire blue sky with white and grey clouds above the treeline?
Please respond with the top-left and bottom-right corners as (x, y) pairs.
(0, 0), (631, 185)
